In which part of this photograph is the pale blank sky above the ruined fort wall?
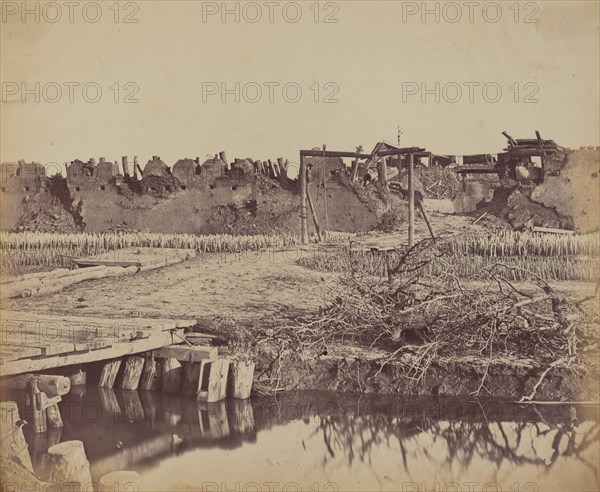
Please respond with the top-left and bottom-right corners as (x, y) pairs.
(0, 0), (600, 171)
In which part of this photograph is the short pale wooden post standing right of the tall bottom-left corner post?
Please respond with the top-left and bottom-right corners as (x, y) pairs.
(48, 441), (92, 489)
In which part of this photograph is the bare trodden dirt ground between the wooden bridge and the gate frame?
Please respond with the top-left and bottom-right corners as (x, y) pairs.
(6, 249), (337, 319)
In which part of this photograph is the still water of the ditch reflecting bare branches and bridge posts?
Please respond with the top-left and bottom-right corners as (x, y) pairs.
(21, 387), (600, 492)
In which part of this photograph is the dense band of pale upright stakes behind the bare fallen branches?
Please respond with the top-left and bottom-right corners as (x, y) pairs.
(300, 231), (600, 281)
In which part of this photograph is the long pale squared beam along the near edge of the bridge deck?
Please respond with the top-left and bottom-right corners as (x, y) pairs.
(0, 329), (183, 376)
